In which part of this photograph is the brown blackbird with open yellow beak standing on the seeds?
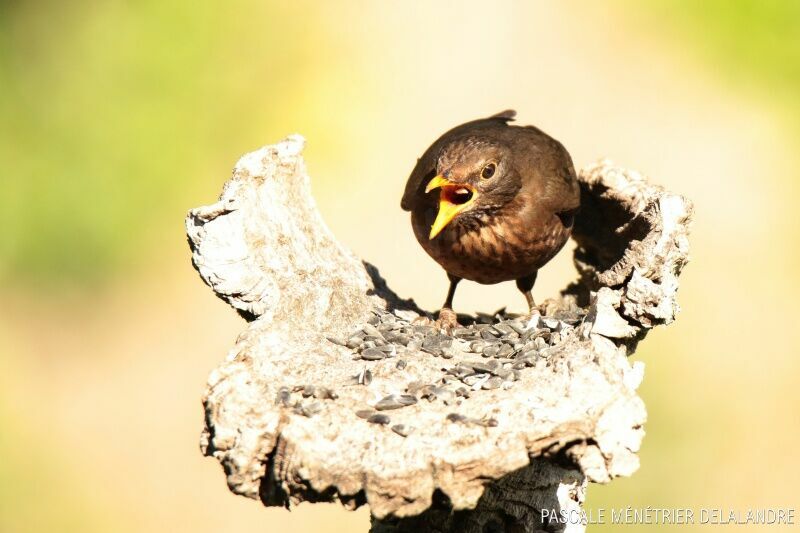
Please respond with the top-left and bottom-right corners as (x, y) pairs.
(401, 110), (580, 329)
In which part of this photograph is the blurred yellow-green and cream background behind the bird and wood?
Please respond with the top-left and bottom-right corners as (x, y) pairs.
(0, 0), (800, 532)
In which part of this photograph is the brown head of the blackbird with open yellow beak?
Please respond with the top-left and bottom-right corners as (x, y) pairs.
(425, 137), (520, 239)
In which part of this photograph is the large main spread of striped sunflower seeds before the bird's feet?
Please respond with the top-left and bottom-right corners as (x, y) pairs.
(328, 307), (585, 436)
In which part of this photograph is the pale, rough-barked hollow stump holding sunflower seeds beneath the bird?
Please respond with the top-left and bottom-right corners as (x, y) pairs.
(186, 135), (692, 532)
